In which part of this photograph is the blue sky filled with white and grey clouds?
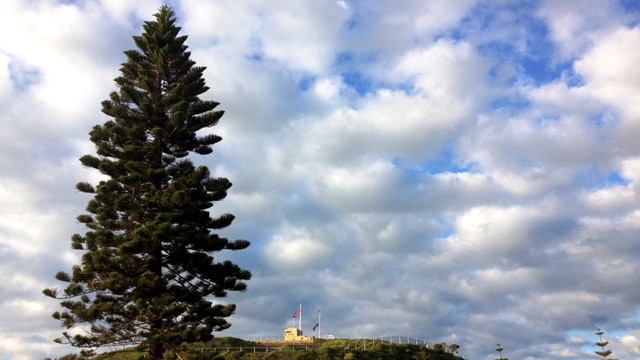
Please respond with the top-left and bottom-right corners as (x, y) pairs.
(0, 0), (640, 360)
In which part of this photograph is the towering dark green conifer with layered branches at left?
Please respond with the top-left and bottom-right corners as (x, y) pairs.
(44, 6), (251, 359)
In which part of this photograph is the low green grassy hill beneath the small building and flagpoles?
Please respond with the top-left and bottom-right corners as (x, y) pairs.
(50, 337), (462, 360)
